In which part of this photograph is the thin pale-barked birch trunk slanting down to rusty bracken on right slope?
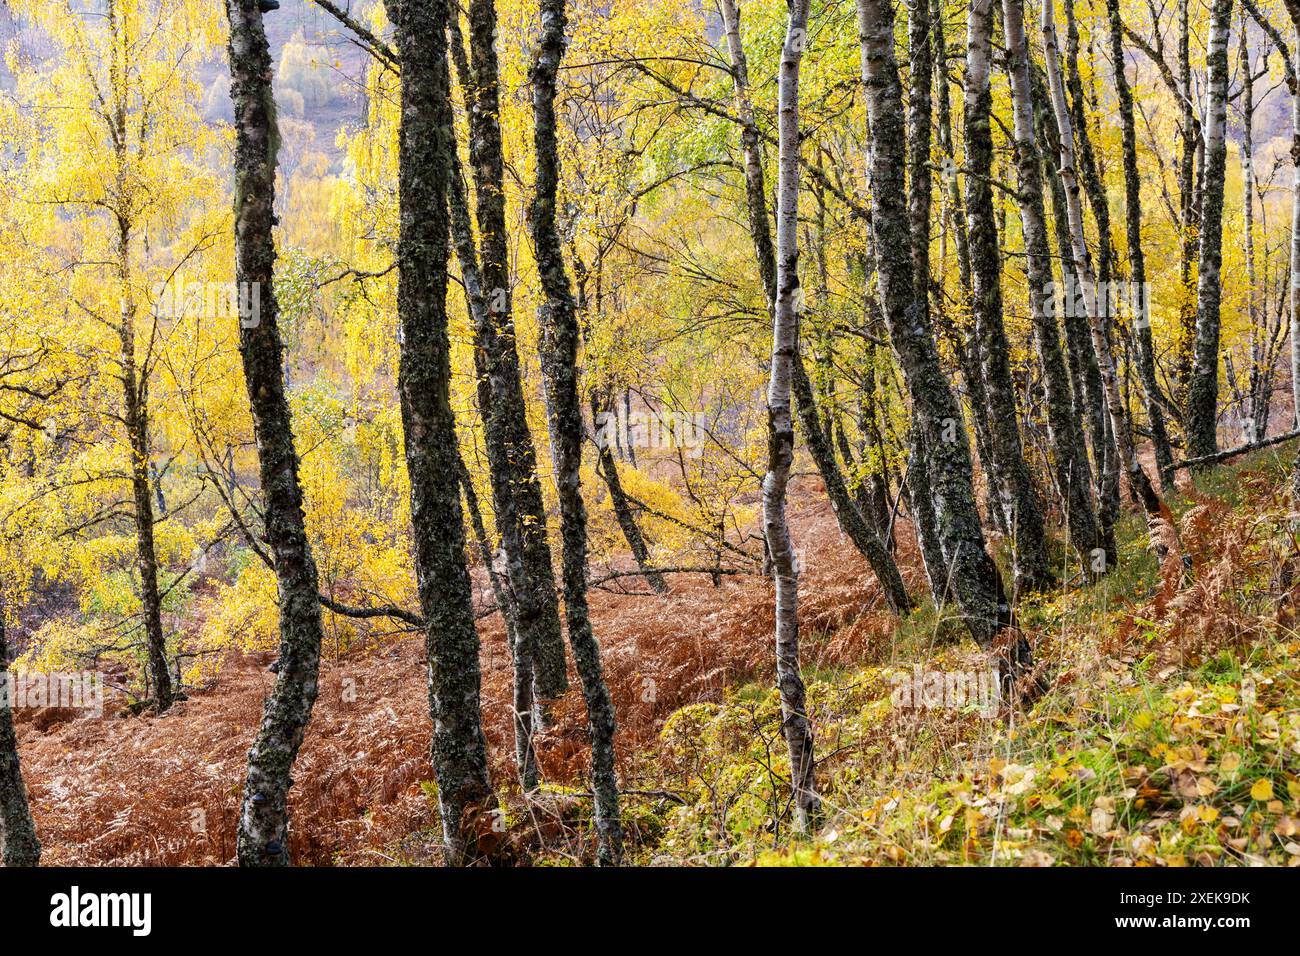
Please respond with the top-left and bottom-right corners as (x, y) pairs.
(1043, 0), (1164, 555)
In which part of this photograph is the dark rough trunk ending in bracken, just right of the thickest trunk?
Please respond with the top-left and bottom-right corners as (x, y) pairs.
(454, 0), (568, 700)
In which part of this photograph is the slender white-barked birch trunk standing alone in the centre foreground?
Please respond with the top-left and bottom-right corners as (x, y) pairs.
(763, 0), (820, 831)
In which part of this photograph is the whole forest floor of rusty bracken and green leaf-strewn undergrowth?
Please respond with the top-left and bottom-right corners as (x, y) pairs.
(18, 444), (1300, 865)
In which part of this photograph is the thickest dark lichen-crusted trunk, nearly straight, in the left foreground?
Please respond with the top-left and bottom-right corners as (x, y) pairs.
(390, 0), (495, 864)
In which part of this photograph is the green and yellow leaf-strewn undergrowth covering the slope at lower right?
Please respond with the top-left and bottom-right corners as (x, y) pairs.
(618, 451), (1300, 866)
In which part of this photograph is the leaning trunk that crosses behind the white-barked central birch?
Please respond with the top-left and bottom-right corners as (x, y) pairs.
(720, 0), (911, 614)
